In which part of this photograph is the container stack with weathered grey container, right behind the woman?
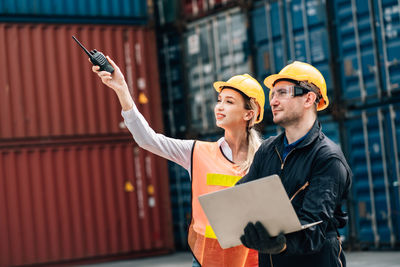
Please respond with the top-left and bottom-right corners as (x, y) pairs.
(155, 0), (251, 249)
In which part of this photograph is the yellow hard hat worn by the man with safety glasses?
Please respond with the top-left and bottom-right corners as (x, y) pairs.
(264, 61), (329, 111)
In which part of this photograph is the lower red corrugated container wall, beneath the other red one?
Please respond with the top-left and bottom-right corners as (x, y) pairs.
(0, 141), (173, 266)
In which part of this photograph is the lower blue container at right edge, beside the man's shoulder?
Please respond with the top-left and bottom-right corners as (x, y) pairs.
(345, 105), (400, 248)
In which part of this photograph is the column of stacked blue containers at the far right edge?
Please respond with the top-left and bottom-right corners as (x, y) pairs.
(332, 0), (400, 247)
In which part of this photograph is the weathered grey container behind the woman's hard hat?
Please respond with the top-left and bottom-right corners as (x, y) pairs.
(184, 8), (252, 134)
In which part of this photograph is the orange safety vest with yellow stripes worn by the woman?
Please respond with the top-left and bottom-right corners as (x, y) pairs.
(188, 141), (258, 267)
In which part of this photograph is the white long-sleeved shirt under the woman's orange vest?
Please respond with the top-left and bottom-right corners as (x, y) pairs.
(121, 104), (232, 177)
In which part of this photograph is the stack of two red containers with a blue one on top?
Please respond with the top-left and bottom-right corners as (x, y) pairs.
(0, 0), (173, 266)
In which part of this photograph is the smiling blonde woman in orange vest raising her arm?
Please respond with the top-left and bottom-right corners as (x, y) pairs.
(92, 57), (265, 267)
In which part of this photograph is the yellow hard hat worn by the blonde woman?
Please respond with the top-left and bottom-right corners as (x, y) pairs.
(214, 74), (265, 123)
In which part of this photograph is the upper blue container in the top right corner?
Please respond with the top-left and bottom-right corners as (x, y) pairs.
(333, 0), (400, 106)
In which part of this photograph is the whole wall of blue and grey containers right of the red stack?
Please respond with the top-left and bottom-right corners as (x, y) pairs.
(155, 0), (400, 251)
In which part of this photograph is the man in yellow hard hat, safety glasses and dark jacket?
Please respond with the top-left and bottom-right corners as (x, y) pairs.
(238, 61), (352, 267)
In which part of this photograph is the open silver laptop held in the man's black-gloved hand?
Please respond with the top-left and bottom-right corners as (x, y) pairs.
(199, 175), (322, 248)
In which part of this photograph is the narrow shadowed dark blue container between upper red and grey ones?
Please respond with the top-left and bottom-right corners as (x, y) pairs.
(158, 31), (188, 137)
